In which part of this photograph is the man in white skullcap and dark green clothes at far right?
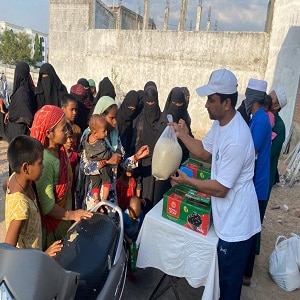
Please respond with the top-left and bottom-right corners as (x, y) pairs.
(269, 88), (287, 196)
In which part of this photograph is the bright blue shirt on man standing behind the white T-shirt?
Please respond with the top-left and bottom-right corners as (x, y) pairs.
(249, 107), (272, 200)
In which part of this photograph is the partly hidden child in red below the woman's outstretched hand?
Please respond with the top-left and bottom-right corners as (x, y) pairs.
(116, 167), (141, 210)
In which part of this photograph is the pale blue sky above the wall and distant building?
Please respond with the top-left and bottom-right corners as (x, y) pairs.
(0, 0), (269, 33)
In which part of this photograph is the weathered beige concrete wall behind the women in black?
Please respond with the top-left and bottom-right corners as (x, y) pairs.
(49, 0), (269, 134)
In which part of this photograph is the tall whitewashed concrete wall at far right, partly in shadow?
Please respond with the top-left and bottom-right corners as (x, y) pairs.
(265, 0), (300, 145)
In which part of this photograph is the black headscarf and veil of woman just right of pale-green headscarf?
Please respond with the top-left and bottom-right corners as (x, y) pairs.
(117, 90), (139, 154)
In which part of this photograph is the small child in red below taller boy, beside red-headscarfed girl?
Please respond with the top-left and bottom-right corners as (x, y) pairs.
(64, 123), (78, 210)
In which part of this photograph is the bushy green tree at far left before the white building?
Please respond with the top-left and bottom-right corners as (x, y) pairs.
(0, 30), (32, 65)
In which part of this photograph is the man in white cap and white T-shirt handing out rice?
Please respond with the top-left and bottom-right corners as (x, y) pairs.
(171, 69), (261, 300)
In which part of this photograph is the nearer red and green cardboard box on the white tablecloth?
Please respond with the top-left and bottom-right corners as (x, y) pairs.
(162, 185), (211, 235)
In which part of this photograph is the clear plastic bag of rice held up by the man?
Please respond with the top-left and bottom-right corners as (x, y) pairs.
(152, 115), (182, 180)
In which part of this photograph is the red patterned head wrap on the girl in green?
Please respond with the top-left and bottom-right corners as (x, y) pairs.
(30, 105), (64, 147)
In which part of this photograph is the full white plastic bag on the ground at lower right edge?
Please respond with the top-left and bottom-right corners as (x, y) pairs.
(269, 235), (300, 292)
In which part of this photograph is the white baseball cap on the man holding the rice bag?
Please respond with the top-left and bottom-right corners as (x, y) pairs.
(196, 69), (238, 96)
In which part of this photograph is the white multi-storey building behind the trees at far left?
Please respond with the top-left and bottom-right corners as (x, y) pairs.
(0, 21), (48, 64)
